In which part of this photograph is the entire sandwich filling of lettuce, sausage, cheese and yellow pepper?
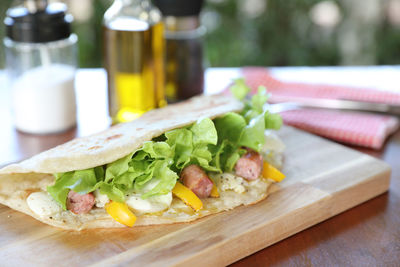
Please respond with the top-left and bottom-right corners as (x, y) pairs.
(27, 79), (284, 226)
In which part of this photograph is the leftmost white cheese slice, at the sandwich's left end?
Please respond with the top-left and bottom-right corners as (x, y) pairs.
(26, 192), (62, 216)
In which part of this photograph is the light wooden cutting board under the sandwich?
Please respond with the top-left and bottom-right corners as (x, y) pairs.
(0, 127), (390, 266)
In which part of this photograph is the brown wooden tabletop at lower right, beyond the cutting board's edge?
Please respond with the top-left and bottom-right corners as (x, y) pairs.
(231, 131), (400, 267)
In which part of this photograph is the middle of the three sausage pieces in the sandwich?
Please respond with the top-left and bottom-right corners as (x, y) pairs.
(181, 165), (213, 198)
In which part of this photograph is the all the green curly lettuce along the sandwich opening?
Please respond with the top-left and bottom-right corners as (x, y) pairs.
(47, 79), (282, 209)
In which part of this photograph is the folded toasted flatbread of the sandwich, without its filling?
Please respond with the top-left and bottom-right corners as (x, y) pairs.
(0, 95), (282, 230)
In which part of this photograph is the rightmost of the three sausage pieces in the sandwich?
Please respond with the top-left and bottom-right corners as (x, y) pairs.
(235, 149), (263, 180)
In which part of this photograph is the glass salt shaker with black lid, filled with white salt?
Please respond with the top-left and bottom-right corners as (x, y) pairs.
(3, 0), (77, 134)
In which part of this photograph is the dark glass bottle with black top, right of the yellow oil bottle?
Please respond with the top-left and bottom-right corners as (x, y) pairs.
(154, 0), (206, 102)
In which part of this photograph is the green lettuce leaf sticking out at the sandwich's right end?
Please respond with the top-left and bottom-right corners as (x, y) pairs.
(211, 79), (282, 171)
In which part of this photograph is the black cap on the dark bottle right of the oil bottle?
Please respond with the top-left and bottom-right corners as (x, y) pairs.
(154, 0), (204, 17)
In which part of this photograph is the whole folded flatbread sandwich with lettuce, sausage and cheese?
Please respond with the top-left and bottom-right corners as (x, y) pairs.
(0, 80), (284, 230)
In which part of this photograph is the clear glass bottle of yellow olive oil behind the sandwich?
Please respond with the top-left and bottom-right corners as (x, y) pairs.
(103, 0), (166, 123)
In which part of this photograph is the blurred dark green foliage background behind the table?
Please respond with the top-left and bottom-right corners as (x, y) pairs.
(0, 0), (400, 68)
